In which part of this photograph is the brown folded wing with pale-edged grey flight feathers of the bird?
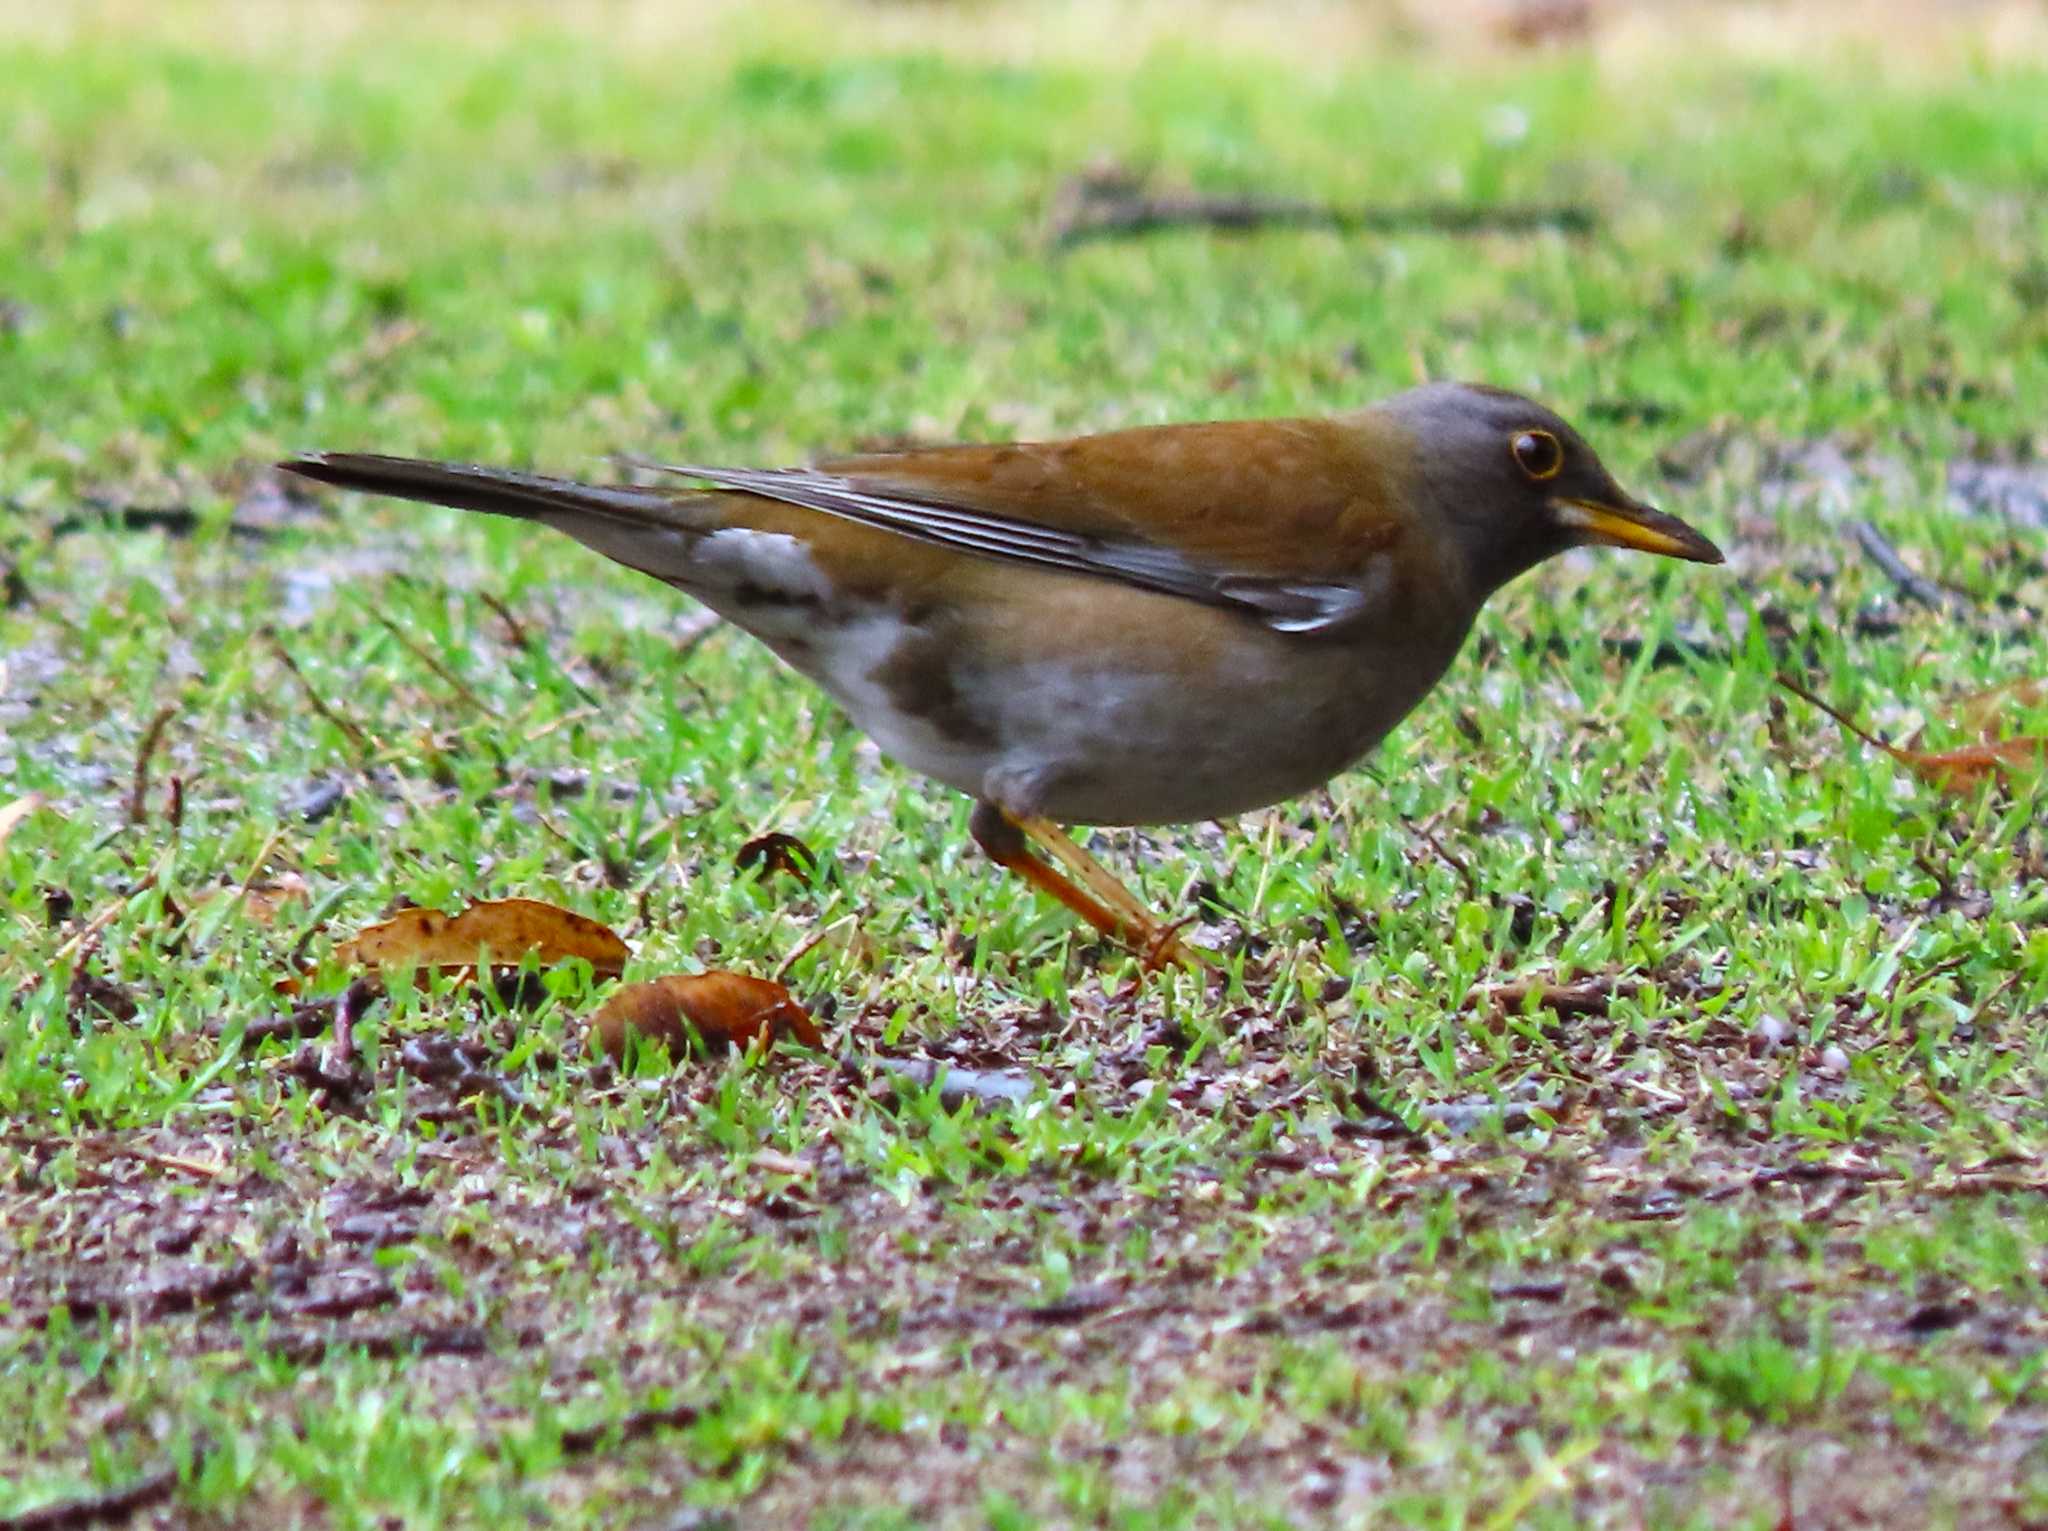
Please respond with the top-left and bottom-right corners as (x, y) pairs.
(655, 415), (1401, 632)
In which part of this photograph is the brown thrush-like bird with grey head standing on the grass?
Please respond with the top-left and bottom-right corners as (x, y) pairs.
(279, 383), (1722, 968)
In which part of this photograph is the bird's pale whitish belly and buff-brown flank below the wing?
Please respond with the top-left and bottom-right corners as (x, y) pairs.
(670, 530), (1464, 825)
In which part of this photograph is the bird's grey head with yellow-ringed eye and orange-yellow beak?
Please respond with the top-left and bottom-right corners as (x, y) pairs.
(1376, 383), (1720, 596)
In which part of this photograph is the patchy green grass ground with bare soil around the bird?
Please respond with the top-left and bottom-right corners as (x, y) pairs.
(0, 8), (2048, 1527)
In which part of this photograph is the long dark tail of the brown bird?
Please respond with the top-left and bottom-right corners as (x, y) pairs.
(279, 452), (705, 532)
